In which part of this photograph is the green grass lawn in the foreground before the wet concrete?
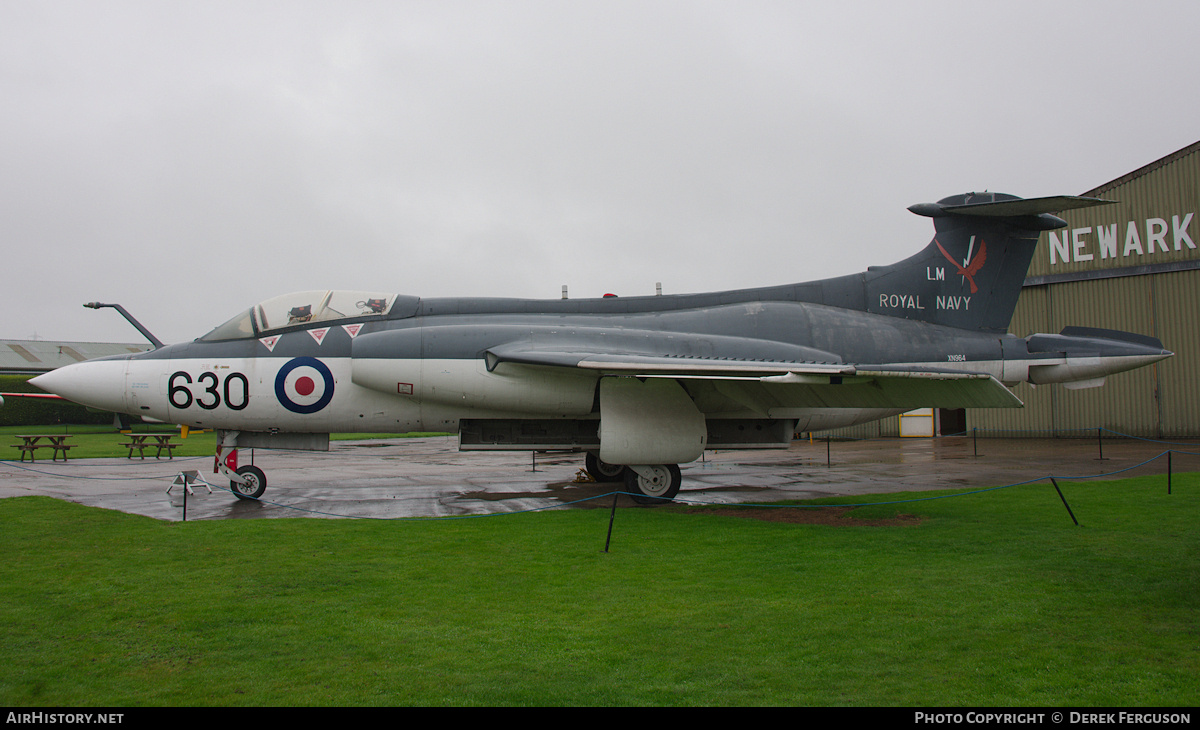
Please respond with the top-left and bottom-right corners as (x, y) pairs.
(0, 474), (1200, 707)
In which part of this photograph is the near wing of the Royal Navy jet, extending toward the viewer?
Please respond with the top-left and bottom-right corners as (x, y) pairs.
(487, 342), (1022, 415)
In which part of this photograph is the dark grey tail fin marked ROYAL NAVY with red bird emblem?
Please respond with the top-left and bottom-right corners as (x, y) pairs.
(865, 192), (1111, 333)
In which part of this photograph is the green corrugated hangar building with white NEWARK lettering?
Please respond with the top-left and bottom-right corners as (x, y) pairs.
(836, 142), (1200, 438)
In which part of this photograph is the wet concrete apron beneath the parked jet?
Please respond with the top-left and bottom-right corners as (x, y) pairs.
(0, 437), (1200, 520)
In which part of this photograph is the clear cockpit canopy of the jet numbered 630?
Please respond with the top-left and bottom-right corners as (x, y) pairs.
(200, 289), (418, 341)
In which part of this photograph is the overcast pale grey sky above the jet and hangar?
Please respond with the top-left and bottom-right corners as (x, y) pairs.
(0, 0), (1200, 342)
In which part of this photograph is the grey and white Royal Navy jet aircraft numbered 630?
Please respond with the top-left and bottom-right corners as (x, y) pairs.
(32, 193), (1171, 502)
